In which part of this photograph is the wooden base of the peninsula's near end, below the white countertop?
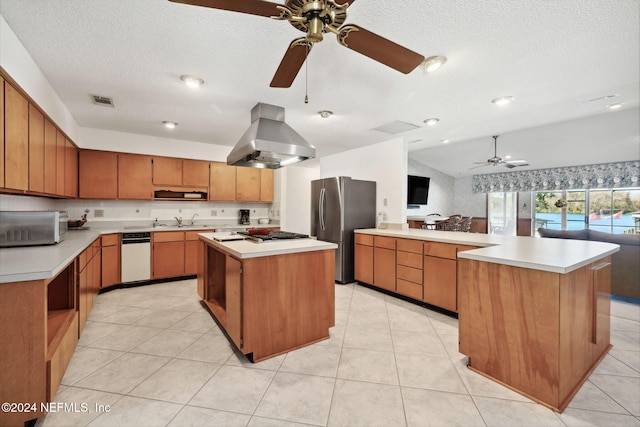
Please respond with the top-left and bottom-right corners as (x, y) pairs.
(458, 257), (611, 412)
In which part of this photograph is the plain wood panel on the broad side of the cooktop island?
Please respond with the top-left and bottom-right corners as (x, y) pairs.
(242, 250), (335, 361)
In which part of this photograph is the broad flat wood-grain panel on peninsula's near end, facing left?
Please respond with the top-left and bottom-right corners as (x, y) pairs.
(458, 259), (560, 408)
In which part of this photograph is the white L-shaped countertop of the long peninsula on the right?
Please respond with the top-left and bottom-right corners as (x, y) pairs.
(356, 228), (620, 274)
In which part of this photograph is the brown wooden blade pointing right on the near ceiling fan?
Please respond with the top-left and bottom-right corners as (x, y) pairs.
(338, 24), (424, 74)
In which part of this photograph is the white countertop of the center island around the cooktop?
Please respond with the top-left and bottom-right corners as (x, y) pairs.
(199, 233), (338, 259)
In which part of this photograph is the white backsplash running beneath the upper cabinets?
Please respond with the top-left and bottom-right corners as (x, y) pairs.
(0, 194), (280, 224)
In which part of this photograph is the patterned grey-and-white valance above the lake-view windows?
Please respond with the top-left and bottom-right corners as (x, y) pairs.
(472, 160), (640, 193)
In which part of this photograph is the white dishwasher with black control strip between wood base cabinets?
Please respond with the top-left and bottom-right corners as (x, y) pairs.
(120, 231), (151, 283)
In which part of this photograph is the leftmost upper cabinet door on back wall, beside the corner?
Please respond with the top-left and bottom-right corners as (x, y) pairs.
(80, 150), (118, 199)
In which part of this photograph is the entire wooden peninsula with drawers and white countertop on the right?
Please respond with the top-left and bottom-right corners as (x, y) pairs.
(356, 229), (618, 412)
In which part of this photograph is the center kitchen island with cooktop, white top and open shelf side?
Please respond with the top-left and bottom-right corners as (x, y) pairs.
(198, 233), (337, 362)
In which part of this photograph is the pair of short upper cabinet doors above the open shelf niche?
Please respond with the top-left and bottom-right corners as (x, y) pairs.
(153, 157), (209, 188)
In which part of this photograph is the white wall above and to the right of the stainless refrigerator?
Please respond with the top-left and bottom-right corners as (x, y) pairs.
(320, 138), (407, 228)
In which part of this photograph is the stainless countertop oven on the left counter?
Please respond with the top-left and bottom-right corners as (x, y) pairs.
(0, 211), (69, 248)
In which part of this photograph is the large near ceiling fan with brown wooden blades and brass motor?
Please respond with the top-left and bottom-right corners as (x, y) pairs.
(169, 0), (424, 88)
